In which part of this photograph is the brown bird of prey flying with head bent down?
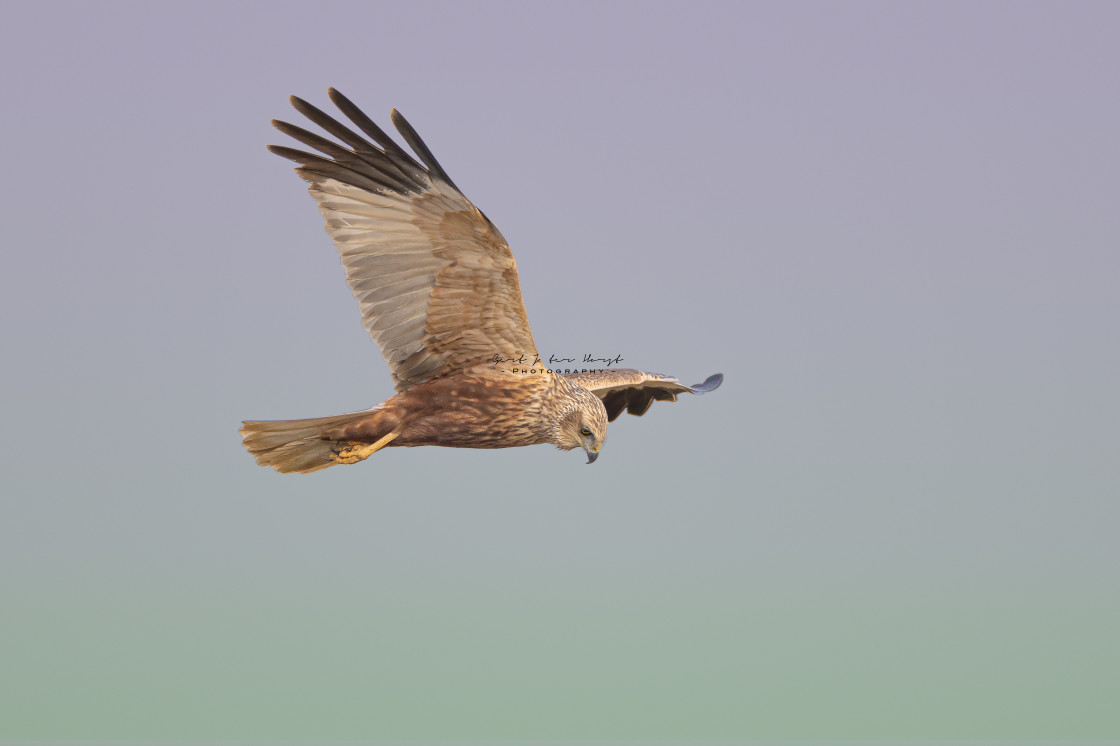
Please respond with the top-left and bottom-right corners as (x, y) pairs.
(241, 88), (724, 473)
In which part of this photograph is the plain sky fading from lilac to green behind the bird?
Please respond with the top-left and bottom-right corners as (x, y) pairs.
(0, 2), (1120, 743)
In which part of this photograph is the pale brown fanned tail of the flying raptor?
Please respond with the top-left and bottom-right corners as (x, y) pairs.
(241, 410), (383, 474)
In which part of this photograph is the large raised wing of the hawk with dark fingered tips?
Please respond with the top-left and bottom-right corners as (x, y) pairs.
(269, 88), (536, 391)
